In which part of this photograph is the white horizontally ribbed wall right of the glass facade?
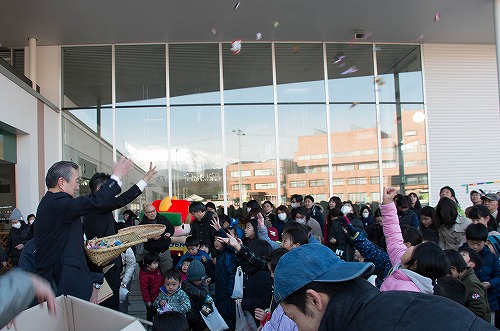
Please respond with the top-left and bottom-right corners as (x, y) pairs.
(422, 44), (500, 208)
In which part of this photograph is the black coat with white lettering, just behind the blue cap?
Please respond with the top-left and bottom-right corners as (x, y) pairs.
(327, 216), (366, 262)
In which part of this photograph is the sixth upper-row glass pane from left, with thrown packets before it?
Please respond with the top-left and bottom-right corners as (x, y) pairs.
(326, 44), (375, 103)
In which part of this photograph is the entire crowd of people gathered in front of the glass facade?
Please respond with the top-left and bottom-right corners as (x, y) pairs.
(0, 159), (500, 331)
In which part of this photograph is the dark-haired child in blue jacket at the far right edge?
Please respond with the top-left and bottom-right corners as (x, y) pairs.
(464, 223), (500, 326)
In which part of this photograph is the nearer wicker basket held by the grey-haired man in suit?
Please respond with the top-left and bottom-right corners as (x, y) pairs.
(85, 232), (147, 266)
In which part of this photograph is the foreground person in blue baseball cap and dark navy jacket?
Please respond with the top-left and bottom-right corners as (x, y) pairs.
(274, 189), (496, 331)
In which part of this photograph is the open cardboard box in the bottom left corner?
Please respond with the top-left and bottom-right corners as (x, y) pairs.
(0, 295), (146, 331)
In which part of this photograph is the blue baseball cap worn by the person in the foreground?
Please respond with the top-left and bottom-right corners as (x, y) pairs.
(274, 244), (375, 303)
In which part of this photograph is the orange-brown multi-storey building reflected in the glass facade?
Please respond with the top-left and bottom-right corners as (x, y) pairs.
(227, 107), (428, 204)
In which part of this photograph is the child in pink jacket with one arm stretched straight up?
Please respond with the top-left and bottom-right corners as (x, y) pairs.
(380, 187), (450, 294)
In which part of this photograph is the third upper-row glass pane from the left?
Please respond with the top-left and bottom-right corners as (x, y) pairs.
(169, 44), (220, 105)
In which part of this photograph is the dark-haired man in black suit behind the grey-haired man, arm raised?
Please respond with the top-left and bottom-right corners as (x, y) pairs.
(83, 164), (156, 311)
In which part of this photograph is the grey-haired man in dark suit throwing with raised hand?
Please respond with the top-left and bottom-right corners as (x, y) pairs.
(34, 158), (133, 300)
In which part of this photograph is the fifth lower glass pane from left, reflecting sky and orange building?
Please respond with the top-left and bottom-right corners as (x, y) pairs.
(278, 105), (329, 202)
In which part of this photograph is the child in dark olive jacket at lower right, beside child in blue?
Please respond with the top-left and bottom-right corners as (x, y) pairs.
(444, 249), (491, 322)
